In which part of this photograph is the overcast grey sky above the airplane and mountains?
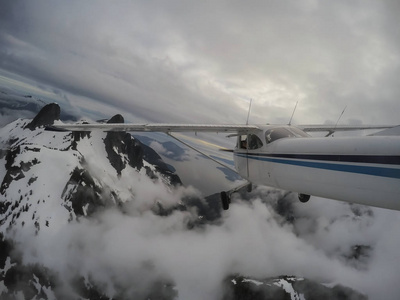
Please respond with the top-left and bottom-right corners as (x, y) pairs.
(0, 0), (400, 124)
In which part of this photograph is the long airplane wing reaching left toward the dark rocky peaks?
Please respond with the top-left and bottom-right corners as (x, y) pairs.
(47, 123), (260, 133)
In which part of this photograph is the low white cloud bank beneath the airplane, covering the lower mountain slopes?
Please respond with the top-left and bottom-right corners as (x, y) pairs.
(6, 173), (400, 299)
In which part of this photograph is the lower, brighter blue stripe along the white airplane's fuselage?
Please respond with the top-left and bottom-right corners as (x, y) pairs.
(236, 153), (400, 179)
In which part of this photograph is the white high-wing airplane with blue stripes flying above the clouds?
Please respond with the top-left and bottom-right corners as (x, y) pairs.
(52, 123), (400, 210)
